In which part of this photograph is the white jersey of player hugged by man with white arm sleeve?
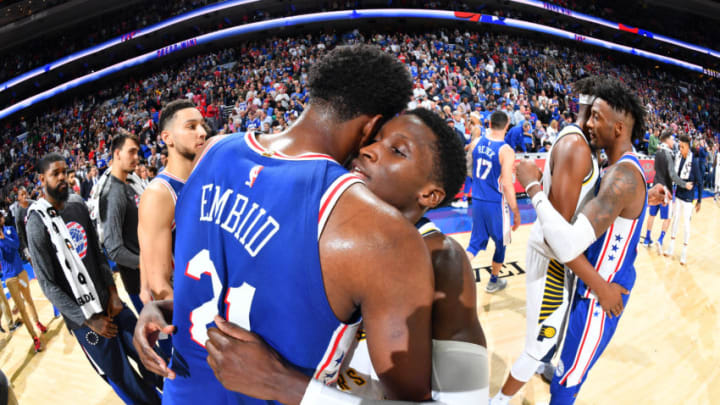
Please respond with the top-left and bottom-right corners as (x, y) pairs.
(528, 124), (600, 262)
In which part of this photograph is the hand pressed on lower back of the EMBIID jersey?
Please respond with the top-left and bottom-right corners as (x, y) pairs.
(205, 316), (310, 404)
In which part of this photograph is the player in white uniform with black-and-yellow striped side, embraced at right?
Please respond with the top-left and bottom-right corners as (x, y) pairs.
(491, 76), (622, 405)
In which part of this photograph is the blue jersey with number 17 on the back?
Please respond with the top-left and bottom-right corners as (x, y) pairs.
(472, 137), (507, 202)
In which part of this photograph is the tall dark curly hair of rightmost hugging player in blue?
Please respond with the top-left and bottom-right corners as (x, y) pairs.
(595, 77), (646, 143)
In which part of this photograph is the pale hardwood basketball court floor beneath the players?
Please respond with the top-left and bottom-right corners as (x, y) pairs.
(0, 198), (720, 405)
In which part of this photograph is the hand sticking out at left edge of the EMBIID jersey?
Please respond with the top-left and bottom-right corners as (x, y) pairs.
(133, 300), (175, 380)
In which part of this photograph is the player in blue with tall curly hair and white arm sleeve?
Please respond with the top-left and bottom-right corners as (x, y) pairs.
(517, 78), (648, 404)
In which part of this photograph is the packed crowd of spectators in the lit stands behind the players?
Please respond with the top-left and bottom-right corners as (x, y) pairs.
(0, 26), (720, 208)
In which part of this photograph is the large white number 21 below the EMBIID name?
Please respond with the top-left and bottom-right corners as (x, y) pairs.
(185, 249), (255, 347)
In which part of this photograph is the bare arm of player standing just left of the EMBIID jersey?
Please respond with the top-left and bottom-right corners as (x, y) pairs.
(138, 183), (175, 300)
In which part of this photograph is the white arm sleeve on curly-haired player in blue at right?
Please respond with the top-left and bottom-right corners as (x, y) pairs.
(532, 191), (597, 263)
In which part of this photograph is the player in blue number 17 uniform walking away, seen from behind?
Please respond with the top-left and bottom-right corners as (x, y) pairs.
(466, 111), (520, 293)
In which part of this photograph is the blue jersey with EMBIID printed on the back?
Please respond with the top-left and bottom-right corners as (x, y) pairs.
(163, 134), (360, 404)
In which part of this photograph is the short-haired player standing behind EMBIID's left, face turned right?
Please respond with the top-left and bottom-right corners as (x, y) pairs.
(138, 99), (207, 303)
